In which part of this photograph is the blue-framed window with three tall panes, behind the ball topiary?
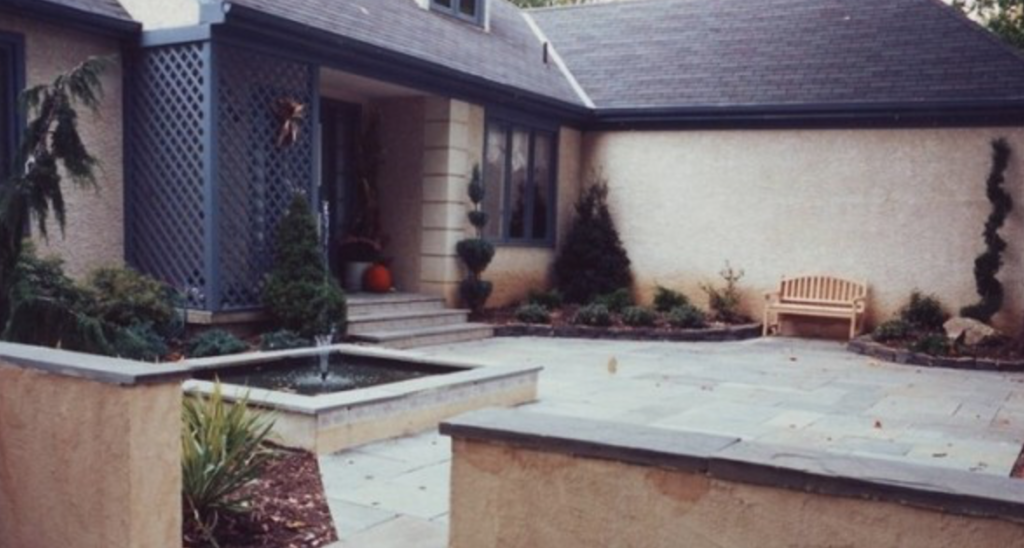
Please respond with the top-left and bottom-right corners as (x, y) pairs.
(483, 119), (557, 245)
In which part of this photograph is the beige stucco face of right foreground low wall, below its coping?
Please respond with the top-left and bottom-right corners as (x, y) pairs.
(450, 438), (1024, 548)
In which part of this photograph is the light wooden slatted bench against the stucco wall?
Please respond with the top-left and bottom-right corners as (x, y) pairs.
(763, 276), (867, 339)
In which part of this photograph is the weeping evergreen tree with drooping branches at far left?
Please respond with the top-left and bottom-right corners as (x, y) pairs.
(0, 57), (112, 326)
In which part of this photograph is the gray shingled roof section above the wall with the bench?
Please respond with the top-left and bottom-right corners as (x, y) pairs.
(530, 0), (1024, 109)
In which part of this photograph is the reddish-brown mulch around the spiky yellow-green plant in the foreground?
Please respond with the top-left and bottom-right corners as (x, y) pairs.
(183, 449), (338, 548)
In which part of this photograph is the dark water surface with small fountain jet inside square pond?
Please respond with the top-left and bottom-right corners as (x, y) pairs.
(196, 352), (465, 395)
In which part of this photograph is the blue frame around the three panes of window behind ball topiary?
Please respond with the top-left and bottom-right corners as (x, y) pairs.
(481, 112), (559, 248)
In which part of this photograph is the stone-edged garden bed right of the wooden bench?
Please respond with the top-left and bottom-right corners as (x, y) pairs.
(847, 335), (1024, 373)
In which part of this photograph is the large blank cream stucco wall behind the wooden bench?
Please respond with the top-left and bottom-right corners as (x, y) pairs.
(583, 128), (1024, 327)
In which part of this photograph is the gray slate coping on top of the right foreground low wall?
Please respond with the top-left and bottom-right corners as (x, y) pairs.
(440, 410), (1024, 521)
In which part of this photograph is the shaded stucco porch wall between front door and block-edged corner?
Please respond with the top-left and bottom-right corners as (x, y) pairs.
(373, 97), (424, 292)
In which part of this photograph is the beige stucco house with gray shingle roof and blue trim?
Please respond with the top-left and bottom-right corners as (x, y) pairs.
(0, 0), (1024, 333)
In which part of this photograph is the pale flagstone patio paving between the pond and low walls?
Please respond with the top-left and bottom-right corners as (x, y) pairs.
(321, 338), (1024, 548)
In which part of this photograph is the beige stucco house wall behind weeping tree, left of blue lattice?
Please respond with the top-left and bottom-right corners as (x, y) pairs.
(0, 14), (124, 277)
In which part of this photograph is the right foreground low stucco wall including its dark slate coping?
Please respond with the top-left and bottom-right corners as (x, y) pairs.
(441, 411), (1024, 548)
